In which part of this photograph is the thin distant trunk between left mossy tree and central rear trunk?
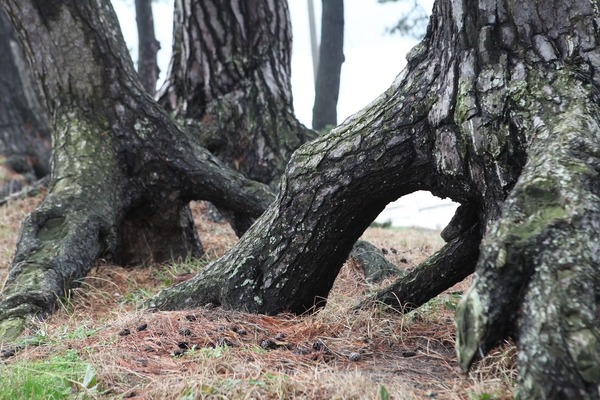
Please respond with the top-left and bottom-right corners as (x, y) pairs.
(135, 0), (160, 96)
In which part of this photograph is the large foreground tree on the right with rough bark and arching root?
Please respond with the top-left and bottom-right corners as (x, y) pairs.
(153, 0), (600, 399)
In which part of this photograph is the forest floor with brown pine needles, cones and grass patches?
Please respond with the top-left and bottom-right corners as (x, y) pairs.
(0, 195), (517, 400)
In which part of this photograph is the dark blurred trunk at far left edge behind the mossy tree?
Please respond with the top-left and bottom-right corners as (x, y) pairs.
(0, 9), (52, 179)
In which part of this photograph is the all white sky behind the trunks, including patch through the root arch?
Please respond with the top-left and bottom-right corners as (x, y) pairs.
(112, 0), (456, 229)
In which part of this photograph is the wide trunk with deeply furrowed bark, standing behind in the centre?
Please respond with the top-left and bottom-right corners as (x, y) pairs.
(159, 0), (315, 187)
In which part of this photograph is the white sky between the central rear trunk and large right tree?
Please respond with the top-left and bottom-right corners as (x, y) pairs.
(289, 0), (431, 126)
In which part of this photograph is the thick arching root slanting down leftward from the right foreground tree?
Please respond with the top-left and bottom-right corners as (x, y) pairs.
(153, 49), (478, 313)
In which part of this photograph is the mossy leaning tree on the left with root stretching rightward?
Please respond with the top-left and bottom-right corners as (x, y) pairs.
(0, 0), (273, 339)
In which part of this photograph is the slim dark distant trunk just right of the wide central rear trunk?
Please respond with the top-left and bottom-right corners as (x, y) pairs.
(312, 0), (344, 131)
